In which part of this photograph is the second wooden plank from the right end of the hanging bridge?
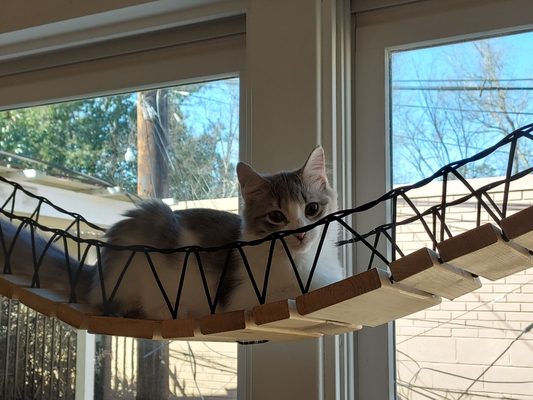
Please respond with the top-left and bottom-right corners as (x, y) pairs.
(437, 224), (533, 281)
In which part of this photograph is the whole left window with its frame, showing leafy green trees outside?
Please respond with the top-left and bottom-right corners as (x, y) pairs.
(0, 10), (244, 398)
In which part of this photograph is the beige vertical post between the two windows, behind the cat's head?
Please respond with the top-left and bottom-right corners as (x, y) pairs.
(239, 0), (353, 400)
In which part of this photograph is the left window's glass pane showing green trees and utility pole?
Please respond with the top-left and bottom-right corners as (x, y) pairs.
(0, 78), (239, 399)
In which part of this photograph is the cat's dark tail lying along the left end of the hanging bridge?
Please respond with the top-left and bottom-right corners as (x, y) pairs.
(0, 217), (95, 302)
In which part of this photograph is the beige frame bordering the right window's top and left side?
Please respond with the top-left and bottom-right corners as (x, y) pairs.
(352, 0), (533, 400)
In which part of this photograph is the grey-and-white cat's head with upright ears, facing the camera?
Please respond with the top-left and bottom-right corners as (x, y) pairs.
(237, 147), (337, 252)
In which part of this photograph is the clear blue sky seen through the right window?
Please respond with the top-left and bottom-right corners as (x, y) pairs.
(390, 32), (533, 184)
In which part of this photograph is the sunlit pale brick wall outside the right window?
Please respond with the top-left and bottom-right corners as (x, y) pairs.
(396, 176), (533, 400)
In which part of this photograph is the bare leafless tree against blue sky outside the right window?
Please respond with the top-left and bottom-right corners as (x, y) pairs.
(392, 40), (532, 183)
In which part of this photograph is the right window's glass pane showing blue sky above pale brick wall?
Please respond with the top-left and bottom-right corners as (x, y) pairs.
(390, 32), (533, 400)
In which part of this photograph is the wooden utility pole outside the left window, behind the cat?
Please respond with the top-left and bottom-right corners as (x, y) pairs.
(136, 89), (170, 400)
